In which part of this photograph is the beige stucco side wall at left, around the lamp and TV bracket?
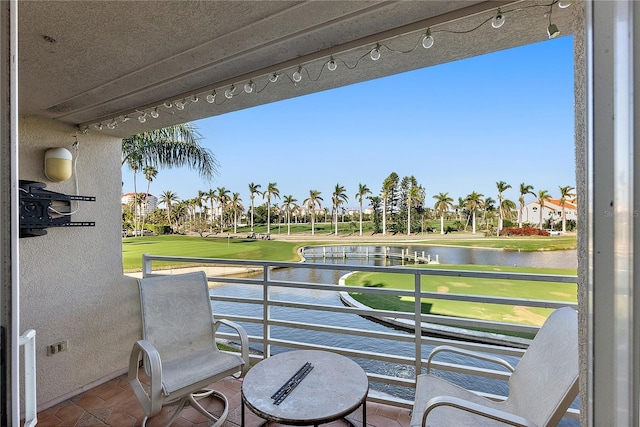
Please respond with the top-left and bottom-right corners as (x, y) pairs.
(19, 117), (140, 409)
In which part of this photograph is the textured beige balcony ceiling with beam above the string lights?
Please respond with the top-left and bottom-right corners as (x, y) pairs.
(18, 0), (573, 136)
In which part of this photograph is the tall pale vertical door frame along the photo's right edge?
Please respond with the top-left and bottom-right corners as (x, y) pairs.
(586, 0), (640, 426)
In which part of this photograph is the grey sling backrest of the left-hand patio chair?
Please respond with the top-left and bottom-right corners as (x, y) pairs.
(138, 271), (217, 363)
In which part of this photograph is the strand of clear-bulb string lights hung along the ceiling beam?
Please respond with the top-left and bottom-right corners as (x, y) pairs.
(85, 0), (572, 130)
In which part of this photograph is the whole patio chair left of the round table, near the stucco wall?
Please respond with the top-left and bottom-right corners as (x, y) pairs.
(128, 272), (249, 427)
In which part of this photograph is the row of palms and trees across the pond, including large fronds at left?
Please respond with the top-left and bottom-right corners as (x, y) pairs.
(122, 124), (575, 235)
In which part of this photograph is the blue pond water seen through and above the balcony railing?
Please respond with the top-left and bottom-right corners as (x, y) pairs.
(212, 246), (579, 426)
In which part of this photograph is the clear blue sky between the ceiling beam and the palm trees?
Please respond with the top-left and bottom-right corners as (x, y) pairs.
(122, 36), (575, 208)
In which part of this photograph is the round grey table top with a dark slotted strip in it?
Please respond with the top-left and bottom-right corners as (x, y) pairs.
(242, 350), (369, 425)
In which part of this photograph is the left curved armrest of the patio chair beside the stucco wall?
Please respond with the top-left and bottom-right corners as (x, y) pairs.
(128, 340), (164, 418)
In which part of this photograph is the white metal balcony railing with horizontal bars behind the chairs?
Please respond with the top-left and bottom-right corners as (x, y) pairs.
(143, 255), (579, 418)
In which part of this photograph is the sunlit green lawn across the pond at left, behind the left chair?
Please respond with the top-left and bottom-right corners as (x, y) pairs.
(122, 235), (301, 272)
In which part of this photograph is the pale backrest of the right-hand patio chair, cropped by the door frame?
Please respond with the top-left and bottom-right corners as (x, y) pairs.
(505, 307), (579, 426)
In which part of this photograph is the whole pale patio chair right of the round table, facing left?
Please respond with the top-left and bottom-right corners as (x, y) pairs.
(410, 307), (578, 427)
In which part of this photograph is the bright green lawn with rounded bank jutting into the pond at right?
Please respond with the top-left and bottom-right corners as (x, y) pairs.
(346, 265), (577, 326)
